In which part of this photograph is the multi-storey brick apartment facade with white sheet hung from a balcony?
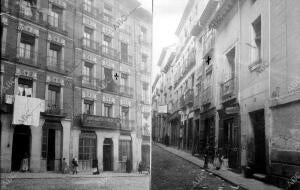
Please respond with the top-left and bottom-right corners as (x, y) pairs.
(1, 0), (152, 172)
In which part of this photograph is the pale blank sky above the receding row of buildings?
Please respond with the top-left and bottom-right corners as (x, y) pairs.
(139, 0), (187, 82)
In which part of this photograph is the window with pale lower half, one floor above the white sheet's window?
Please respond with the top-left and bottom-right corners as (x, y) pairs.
(19, 33), (35, 59)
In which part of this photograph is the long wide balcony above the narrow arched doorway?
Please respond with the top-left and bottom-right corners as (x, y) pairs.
(81, 114), (121, 130)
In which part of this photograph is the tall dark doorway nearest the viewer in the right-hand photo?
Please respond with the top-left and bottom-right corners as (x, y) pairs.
(250, 109), (266, 173)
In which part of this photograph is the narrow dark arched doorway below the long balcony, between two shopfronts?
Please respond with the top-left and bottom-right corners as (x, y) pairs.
(103, 138), (113, 171)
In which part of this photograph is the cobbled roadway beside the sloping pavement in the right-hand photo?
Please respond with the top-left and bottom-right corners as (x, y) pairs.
(151, 144), (241, 190)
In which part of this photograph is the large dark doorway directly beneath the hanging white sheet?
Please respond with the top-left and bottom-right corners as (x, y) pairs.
(11, 125), (31, 171)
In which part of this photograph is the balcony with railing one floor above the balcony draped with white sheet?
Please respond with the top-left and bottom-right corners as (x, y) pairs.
(16, 46), (41, 67)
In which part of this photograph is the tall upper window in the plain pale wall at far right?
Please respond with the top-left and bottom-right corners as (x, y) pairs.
(251, 16), (261, 61)
